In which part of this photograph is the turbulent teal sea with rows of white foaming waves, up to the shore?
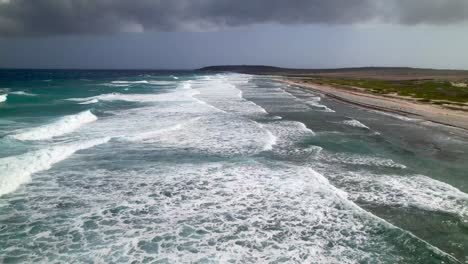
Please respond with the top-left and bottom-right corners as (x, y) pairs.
(0, 70), (468, 263)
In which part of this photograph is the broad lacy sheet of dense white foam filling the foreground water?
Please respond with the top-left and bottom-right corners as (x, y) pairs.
(23, 160), (452, 264)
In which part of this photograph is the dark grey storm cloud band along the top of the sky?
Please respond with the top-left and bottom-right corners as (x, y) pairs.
(0, 0), (468, 36)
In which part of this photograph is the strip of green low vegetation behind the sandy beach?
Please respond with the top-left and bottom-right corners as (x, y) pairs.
(304, 78), (468, 106)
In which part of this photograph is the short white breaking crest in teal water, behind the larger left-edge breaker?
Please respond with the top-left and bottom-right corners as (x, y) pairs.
(9, 110), (97, 140)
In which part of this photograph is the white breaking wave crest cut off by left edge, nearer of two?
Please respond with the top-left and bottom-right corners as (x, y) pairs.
(0, 138), (110, 196)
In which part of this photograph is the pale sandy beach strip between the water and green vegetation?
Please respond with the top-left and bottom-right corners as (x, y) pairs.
(279, 79), (468, 132)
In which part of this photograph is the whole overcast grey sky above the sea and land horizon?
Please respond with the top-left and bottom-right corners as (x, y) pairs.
(0, 0), (468, 69)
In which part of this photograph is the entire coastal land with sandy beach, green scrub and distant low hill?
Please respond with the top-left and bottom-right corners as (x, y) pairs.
(200, 65), (468, 130)
